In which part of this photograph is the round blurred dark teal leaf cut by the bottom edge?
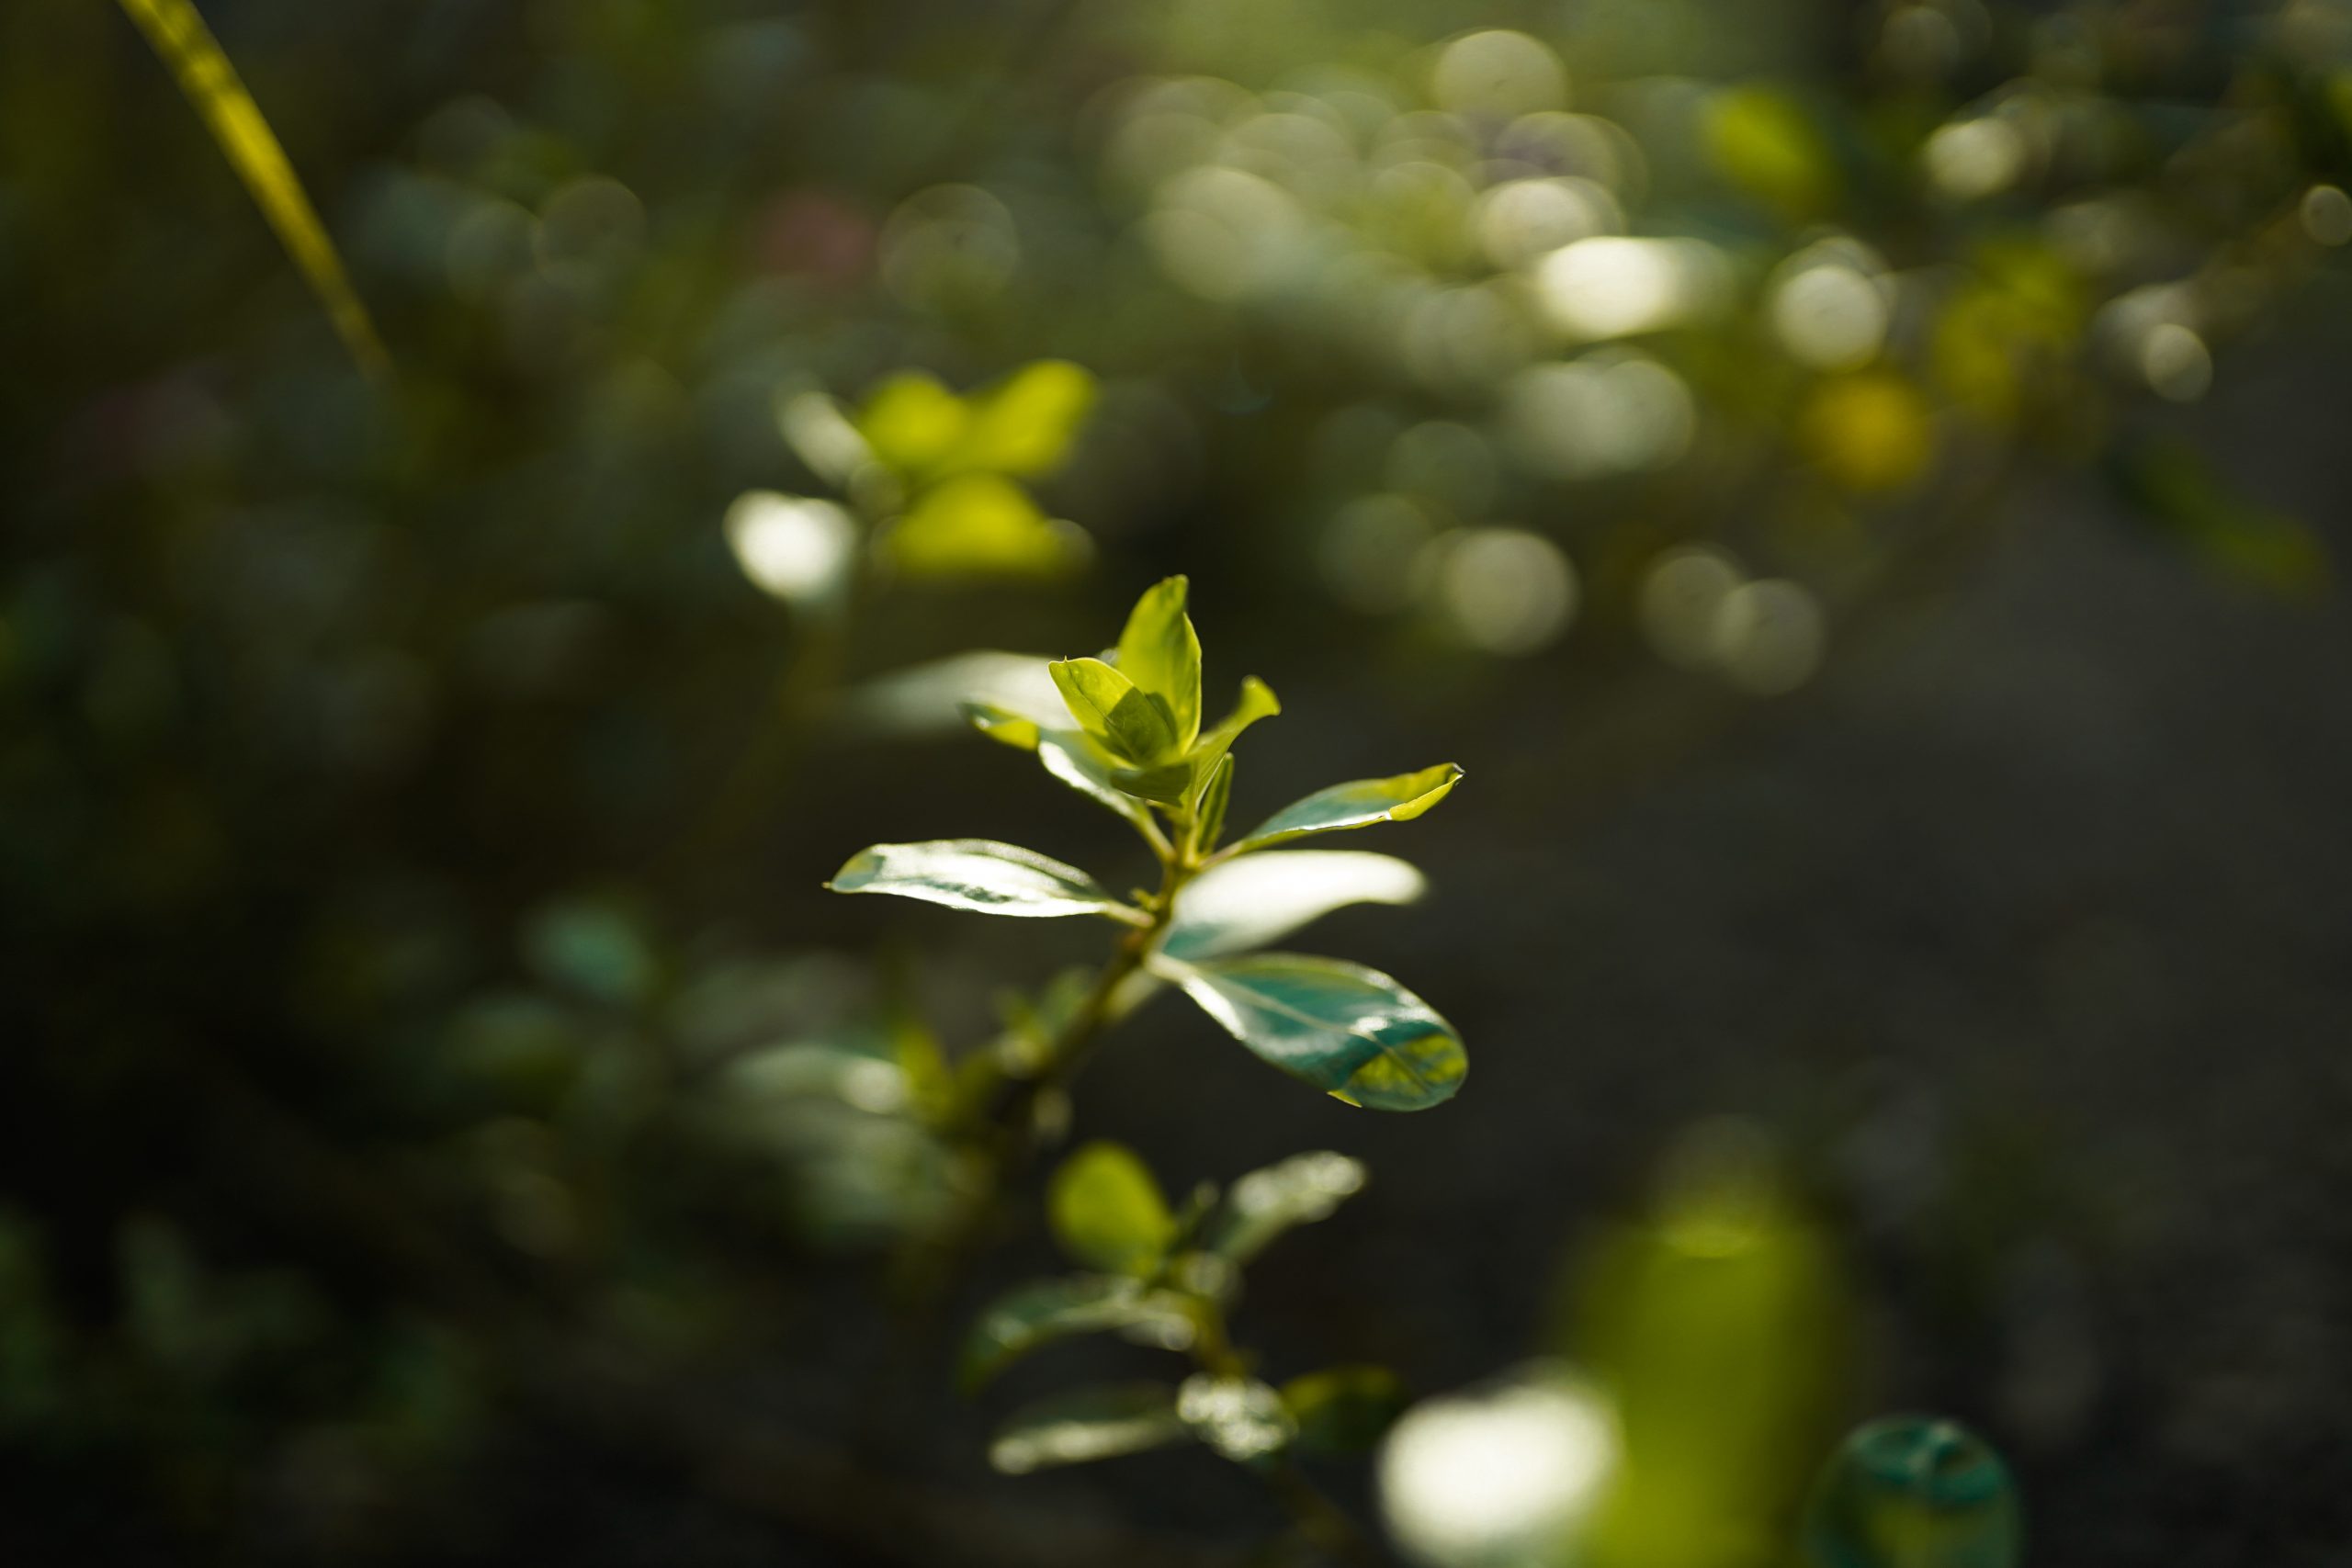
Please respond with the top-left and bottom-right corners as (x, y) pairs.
(1804, 1416), (2023, 1568)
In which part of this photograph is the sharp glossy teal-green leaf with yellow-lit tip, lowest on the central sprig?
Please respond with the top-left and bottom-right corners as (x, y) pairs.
(1171, 952), (1470, 1110)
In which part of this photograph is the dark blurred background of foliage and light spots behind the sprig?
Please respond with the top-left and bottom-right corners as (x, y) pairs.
(0, 0), (2352, 1563)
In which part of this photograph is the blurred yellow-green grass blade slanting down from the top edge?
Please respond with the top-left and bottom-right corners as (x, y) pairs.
(122, 0), (393, 376)
